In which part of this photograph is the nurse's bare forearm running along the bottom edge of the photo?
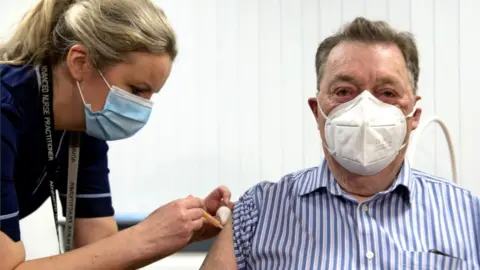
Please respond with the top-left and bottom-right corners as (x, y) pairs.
(15, 227), (161, 270)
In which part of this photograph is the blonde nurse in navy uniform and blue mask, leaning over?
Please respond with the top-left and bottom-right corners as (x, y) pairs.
(0, 0), (232, 269)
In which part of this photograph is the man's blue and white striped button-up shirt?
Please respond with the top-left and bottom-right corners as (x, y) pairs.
(233, 161), (480, 270)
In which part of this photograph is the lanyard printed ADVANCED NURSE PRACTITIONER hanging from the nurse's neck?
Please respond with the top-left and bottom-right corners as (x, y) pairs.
(39, 63), (81, 253)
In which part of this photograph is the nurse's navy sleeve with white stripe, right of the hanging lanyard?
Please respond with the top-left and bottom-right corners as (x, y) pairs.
(58, 134), (114, 218)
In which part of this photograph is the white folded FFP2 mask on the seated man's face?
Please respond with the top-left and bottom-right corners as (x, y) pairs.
(319, 90), (415, 175)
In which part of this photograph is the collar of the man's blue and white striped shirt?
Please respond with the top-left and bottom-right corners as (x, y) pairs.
(298, 159), (416, 203)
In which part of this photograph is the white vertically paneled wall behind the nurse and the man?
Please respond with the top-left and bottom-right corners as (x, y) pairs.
(0, 0), (480, 269)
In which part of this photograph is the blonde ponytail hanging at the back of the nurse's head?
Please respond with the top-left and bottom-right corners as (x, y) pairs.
(0, 0), (75, 65)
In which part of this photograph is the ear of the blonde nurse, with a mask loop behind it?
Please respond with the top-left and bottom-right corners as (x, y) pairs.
(65, 44), (92, 82)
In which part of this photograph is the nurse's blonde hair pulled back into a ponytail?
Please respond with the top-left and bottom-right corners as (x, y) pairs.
(0, 0), (177, 68)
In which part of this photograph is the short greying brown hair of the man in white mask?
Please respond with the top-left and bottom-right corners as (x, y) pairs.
(315, 17), (420, 94)
